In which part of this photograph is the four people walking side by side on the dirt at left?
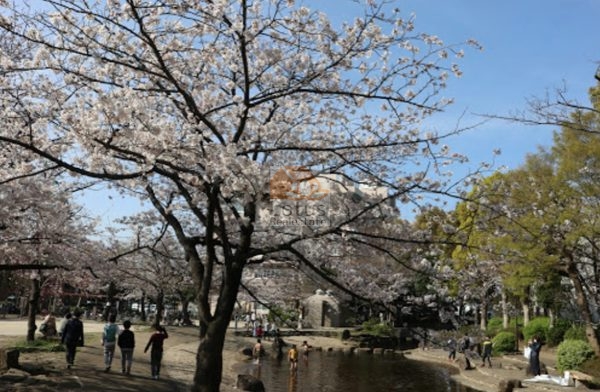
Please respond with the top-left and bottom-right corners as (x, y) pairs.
(58, 311), (169, 380)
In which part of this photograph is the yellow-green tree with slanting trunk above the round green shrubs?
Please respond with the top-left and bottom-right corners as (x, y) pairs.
(492, 87), (600, 353)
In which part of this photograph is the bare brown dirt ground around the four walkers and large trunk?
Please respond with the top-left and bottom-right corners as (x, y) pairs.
(0, 319), (252, 392)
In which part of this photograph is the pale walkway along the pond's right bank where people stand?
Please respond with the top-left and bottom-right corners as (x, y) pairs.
(405, 349), (587, 392)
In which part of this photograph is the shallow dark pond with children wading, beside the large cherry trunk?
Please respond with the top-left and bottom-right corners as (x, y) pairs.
(238, 351), (476, 392)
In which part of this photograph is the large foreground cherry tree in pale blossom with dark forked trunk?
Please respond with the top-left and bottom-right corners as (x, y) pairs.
(0, 0), (477, 392)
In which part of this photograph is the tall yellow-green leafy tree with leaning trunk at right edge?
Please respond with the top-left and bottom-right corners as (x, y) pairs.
(496, 85), (600, 354)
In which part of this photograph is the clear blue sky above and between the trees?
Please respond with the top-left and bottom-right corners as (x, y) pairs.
(79, 0), (600, 228)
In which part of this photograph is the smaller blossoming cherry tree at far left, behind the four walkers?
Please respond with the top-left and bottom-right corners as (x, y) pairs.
(0, 145), (92, 341)
